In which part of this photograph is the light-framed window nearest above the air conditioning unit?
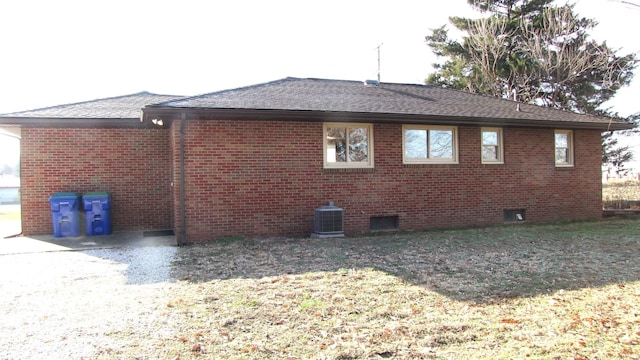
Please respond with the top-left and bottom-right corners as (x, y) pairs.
(323, 123), (373, 168)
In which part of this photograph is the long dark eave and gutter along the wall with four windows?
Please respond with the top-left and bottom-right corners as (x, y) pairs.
(141, 106), (635, 131)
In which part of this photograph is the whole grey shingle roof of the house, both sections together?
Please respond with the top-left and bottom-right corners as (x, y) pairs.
(0, 78), (632, 131)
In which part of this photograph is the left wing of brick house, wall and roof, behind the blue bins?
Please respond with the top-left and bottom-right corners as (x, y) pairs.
(0, 92), (178, 242)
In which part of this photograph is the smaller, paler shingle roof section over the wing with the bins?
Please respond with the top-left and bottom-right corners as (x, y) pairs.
(0, 91), (181, 119)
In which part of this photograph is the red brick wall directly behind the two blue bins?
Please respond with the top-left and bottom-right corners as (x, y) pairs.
(21, 127), (173, 235)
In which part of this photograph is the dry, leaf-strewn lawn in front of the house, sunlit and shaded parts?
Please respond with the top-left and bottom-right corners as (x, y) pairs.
(126, 219), (640, 359)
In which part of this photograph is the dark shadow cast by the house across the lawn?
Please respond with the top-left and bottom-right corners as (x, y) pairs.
(171, 218), (640, 302)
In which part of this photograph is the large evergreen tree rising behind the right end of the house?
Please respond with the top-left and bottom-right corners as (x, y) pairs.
(426, 0), (638, 170)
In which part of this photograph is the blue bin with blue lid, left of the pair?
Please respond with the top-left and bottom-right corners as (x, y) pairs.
(49, 192), (80, 237)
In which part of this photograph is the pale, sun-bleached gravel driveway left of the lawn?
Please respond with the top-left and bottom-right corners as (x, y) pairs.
(0, 239), (179, 359)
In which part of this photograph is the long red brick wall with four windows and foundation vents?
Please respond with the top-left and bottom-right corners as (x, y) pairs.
(172, 121), (602, 241)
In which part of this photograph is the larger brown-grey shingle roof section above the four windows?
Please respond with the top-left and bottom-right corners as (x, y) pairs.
(144, 78), (631, 130)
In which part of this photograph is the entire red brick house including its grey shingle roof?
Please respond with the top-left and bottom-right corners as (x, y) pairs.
(0, 78), (631, 243)
